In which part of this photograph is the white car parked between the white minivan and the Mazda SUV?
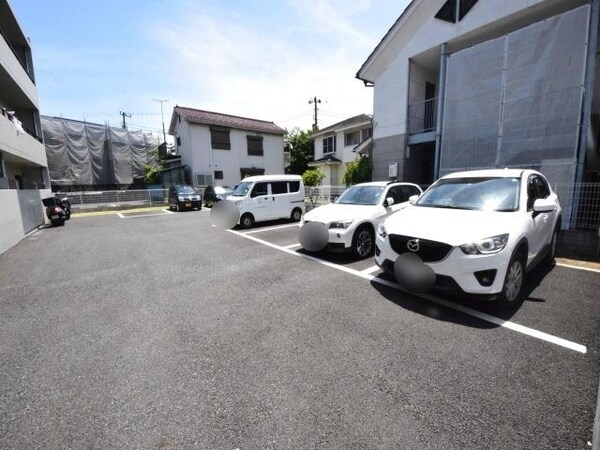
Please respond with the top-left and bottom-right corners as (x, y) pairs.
(300, 181), (423, 258)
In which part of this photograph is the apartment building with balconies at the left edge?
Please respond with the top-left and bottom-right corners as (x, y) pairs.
(0, 0), (50, 253)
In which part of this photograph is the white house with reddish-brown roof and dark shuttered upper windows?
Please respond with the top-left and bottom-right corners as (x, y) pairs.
(169, 106), (285, 186)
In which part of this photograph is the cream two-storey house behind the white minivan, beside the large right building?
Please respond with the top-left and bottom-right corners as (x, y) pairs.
(309, 114), (373, 186)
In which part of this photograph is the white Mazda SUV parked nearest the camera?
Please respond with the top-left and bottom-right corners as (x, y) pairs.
(375, 169), (561, 306)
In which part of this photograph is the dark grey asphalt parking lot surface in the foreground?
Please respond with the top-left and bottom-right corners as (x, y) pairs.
(0, 210), (600, 449)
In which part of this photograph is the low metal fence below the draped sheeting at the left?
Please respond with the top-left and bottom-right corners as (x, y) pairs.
(56, 189), (168, 209)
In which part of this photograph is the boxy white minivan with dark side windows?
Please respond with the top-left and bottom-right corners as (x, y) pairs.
(227, 175), (304, 228)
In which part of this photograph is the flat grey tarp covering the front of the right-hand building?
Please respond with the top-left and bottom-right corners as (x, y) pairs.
(440, 5), (590, 225)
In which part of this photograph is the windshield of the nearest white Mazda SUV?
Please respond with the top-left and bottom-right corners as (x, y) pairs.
(416, 177), (519, 211)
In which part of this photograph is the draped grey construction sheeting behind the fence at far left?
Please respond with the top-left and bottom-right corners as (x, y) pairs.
(42, 117), (160, 186)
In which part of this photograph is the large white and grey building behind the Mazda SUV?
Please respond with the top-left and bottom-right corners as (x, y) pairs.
(357, 0), (600, 226)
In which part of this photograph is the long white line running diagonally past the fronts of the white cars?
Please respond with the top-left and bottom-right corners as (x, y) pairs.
(227, 230), (587, 354)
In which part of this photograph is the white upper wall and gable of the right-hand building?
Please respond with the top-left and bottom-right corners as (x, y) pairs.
(370, 0), (588, 139)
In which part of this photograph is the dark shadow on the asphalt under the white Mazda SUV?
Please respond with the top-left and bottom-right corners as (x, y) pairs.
(371, 264), (553, 329)
